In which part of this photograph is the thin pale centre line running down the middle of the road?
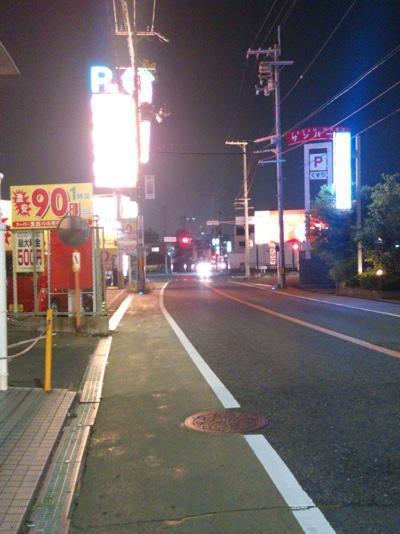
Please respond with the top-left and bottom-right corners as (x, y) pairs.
(203, 282), (400, 358)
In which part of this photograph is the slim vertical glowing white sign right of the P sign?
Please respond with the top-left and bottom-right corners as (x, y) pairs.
(333, 132), (351, 210)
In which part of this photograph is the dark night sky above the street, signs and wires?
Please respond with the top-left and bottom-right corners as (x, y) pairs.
(0, 0), (400, 235)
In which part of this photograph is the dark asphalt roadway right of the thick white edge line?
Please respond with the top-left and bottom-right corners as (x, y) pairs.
(164, 277), (400, 534)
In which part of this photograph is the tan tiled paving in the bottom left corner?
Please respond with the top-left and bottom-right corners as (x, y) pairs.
(0, 388), (75, 533)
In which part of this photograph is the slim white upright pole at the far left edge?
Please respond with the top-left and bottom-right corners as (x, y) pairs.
(0, 174), (8, 391)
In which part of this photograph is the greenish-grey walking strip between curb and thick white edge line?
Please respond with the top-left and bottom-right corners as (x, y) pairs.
(70, 291), (310, 534)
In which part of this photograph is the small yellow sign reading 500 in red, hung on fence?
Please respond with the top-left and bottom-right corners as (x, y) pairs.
(14, 231), (44, 273)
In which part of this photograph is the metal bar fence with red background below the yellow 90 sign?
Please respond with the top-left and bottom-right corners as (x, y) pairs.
(6, 227), (105, 316)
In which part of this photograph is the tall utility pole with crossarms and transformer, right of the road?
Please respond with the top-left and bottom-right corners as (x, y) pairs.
(247, 27), (293, 289)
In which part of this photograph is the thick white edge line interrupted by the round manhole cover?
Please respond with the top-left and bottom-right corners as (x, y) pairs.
(160, 282), (335, 534)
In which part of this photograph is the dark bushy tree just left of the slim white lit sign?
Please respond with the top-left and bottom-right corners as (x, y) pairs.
(310, 186), (357, 283)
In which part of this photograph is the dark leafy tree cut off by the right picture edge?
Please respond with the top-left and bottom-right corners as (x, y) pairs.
(357, 174), (400, 273)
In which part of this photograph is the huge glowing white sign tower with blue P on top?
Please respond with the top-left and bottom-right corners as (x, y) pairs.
(90, 66), (155, 188)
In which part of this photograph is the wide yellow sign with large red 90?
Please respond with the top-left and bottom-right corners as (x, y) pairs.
(10, 183), (93, 228)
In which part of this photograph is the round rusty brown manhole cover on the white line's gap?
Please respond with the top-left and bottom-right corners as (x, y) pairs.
(185, 410), (267, 434)
